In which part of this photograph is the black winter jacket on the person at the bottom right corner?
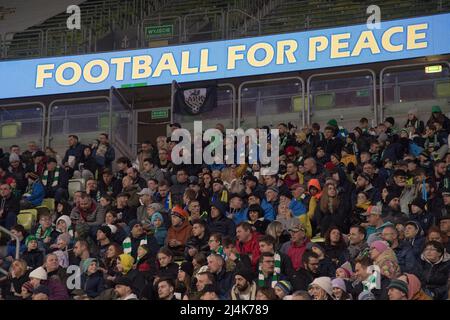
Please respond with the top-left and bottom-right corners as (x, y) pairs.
(420, 254), (450, 300)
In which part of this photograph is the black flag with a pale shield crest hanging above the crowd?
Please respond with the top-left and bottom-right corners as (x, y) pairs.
(174, 84), (217, 116)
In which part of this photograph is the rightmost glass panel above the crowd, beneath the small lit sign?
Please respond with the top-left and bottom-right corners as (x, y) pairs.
(382, 64), (450, 126)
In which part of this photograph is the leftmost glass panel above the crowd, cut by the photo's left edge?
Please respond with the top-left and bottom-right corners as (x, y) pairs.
(0, 105), (44, 152)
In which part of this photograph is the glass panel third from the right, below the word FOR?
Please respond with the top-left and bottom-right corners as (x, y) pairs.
(240, 79), (302, 129)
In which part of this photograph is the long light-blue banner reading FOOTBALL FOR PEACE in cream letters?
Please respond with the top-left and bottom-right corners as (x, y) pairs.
(0, 14), (450, 99)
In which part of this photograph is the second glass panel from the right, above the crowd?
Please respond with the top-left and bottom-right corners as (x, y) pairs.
(310, 74), (374, 127)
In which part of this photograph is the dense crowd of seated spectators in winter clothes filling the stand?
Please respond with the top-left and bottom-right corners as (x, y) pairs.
(0, 106), (450, 300)
